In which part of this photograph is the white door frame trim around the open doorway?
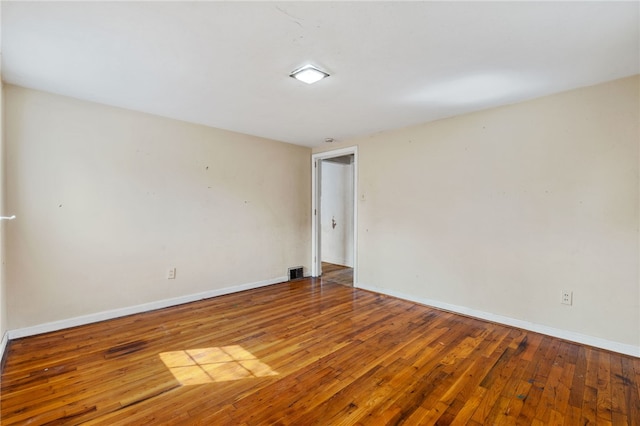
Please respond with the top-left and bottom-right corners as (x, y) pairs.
(311, 146), (358, 287)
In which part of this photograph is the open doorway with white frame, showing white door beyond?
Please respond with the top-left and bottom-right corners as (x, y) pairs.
(311, 147), (357, 286)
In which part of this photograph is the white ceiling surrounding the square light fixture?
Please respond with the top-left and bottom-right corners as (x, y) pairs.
(1, 1), (640, 146)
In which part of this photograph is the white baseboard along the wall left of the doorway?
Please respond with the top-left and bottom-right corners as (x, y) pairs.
(3, 277), (288, 340)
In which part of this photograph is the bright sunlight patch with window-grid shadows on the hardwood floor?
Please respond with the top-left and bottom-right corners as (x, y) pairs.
(160, 345), (278, 385)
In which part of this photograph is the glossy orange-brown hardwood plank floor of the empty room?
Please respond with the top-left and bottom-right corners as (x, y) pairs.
(0, 279), (640, 425)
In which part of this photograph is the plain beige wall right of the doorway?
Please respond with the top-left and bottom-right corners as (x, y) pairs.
(317, 76), (640, 353)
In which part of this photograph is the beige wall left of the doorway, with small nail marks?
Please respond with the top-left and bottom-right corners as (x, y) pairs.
(5, 86), (311, 329)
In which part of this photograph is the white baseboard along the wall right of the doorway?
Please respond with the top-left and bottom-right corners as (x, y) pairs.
(356, 283), (640, 358)
